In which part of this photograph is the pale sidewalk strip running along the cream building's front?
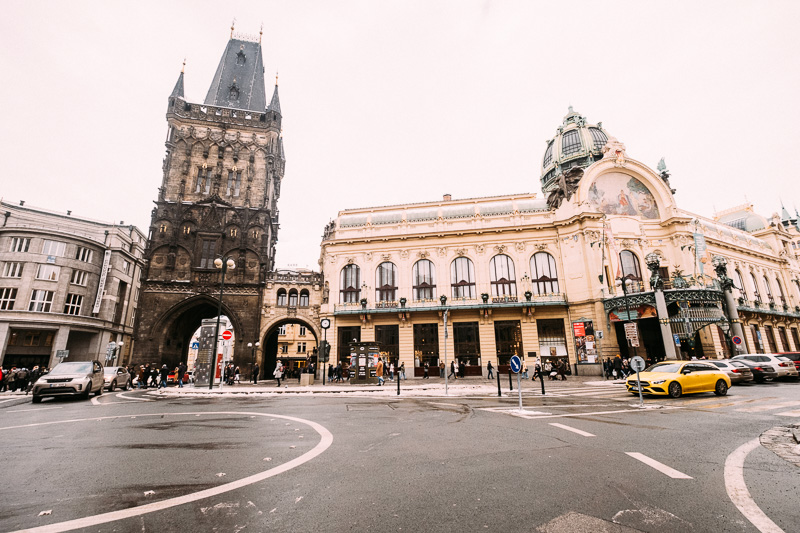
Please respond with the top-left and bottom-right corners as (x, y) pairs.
(151, 374), (624, 396)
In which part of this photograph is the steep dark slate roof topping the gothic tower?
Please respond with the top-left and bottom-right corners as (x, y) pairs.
(205, 39), (266, 112)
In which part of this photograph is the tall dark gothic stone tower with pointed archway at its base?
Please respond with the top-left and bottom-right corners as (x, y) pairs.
(134, 34), (285, 366)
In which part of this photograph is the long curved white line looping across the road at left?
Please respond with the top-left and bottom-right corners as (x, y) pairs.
(0, 411), (333, 533)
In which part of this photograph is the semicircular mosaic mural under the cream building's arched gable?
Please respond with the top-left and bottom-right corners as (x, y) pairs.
(589, 172), (658, 218)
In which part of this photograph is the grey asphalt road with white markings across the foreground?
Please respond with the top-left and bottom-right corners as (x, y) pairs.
(0, 382), (800, 533)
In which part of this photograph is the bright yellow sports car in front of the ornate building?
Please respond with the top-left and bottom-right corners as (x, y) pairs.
(625, 361), (731, 398)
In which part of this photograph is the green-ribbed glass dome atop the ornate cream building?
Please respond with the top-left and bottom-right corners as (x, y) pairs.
(541, 106), (608, 194)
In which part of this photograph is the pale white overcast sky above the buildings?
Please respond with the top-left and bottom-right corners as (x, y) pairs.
(0, 0), (800, 269)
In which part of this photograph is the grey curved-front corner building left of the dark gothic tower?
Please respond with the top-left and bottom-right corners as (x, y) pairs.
(0, 202), (145, 368)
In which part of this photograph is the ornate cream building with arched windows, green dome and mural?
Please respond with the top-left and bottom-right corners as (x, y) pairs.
(320, 108), (800, 376)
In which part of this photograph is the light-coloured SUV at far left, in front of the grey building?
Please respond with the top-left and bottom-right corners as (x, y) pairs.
(33, 361), (103, 403)
